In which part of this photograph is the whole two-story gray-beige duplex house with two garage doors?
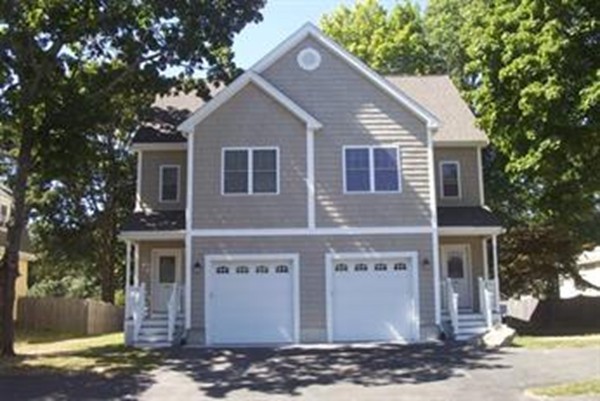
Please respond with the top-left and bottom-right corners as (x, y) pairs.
(121, 24), (502, 346)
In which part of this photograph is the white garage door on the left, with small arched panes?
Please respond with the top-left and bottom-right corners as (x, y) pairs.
(207, 258), (297, 344)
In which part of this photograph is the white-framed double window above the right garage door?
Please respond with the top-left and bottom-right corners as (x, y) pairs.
(344, 146), (401, 192)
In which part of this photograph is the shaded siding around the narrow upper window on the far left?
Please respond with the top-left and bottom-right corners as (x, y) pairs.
(138, 150), (187, 210)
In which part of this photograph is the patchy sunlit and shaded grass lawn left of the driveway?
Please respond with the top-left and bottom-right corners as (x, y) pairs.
(0, 332), (162, 376)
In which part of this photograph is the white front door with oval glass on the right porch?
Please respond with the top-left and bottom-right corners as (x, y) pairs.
(442, 244), (473, 309)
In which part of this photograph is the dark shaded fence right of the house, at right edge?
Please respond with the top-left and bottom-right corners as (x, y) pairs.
(506, 296), (600, 335)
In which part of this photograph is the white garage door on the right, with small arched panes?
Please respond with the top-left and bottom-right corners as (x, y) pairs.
(329, 253), (418, 341)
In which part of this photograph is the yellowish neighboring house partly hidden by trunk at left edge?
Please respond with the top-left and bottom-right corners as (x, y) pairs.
(0, 184), (35, 318)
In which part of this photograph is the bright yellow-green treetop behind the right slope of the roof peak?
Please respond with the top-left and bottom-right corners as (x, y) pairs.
(321, 0), (443, 74)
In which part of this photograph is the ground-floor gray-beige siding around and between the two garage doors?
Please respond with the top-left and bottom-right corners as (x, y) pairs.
(192, 234), (435, 342)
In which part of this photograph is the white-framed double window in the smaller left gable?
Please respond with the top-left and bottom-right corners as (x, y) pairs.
(222, 148), (279, 194)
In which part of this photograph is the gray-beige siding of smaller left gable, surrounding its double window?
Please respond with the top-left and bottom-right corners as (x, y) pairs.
(193, 84), (307, 229)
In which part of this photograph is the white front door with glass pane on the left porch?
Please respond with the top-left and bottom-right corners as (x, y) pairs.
(152, 249), (181, 312)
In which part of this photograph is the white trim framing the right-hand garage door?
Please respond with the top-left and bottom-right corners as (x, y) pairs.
(325, 251), (420, 343)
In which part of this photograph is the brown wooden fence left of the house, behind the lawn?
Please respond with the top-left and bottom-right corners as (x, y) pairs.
(17, 297), (123, 335)
